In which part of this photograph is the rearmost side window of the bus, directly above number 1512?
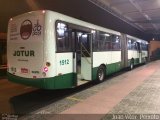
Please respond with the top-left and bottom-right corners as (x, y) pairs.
(56, 22), (72, 52)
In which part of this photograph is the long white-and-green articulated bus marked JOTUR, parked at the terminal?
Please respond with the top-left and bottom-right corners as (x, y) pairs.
(7, 10), (148, 89)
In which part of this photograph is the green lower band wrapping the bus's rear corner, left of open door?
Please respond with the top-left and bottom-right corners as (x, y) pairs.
(7, 73), (76, 89)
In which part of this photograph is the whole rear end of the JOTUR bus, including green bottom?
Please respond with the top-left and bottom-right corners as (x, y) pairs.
(7, 11), (47, 88)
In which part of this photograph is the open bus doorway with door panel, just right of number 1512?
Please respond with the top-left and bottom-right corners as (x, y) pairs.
(74, 31), (92, 81)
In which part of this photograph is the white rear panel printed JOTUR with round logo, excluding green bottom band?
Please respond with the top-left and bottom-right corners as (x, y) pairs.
(8, 12), (44, 78)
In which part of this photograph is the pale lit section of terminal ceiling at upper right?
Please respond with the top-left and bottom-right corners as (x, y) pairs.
(90, 0), (160, 34)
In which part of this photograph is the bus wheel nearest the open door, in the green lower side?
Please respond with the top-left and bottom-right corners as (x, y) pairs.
(97, 65), (106, 82)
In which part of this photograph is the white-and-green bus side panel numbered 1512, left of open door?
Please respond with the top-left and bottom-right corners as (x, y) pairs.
(55, 53), (77, 88)
